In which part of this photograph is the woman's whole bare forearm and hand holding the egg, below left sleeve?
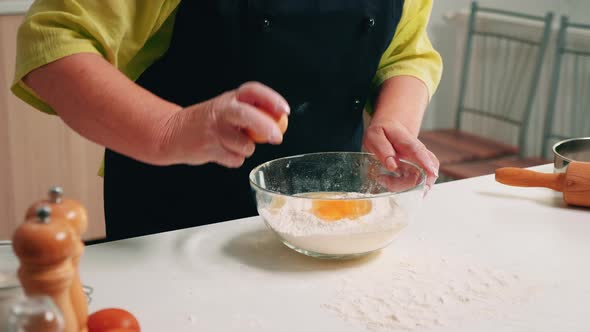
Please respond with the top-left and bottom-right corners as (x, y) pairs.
(23, 53), (289, 167)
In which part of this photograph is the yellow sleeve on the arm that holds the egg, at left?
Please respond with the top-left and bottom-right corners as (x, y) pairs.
(11, 0), (180, 114)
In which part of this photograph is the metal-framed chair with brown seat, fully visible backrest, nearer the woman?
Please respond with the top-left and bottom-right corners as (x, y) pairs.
(419, 2), (553, 169)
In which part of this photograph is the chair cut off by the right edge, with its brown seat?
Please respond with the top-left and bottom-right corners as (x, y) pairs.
(444, 16), (590, 179)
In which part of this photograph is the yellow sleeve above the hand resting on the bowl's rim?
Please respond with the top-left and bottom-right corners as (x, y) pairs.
(373, 0), (443, 97)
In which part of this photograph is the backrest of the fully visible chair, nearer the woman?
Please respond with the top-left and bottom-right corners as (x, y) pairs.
(455, 2), (553, 154)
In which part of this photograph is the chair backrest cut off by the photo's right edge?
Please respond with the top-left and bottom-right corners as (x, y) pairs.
(541, 16), (590, 157)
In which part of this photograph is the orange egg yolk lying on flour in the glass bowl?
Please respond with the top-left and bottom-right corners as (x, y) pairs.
(308, 194), (373, 222)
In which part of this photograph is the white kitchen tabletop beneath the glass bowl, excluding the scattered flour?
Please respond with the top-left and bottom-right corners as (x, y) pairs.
(1, 165), (590, 332)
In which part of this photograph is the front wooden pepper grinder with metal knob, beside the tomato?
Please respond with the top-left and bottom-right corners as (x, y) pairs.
(12, 206), (79, 332)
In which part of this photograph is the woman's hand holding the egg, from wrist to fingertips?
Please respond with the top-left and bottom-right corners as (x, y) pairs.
(159, 82), (290, 168)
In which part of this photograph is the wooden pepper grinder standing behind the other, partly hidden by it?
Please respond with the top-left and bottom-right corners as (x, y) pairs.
(26, 186), (88, 332)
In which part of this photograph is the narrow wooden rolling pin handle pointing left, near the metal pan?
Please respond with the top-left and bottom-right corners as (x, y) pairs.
(496, 167), (564, 191)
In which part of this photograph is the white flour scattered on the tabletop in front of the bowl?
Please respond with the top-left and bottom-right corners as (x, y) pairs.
(322, 258), (532, 331)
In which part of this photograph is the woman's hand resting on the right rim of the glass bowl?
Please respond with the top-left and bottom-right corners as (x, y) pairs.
(363, 120), (440, 190)
